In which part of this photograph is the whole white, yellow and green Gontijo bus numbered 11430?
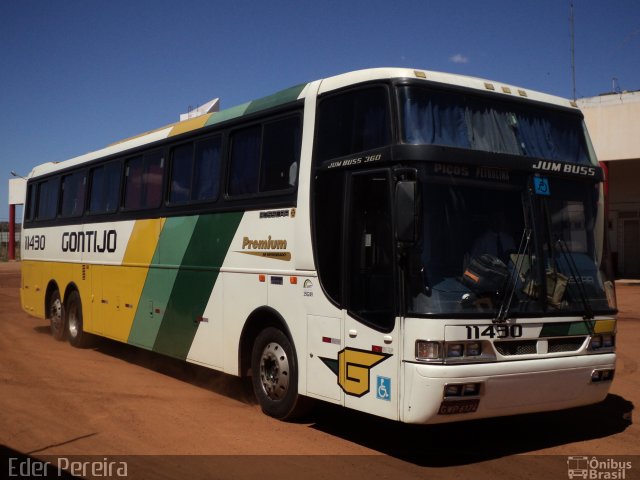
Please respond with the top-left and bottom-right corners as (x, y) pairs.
(21, 68), (616, 423)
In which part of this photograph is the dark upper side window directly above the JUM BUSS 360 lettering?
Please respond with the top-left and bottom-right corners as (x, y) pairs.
(316, 87), (391, 160)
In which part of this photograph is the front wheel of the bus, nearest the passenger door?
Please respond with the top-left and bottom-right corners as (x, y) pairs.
(251, 327), (304, 420)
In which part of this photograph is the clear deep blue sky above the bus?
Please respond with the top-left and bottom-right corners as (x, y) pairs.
(0, 0), (640, 220)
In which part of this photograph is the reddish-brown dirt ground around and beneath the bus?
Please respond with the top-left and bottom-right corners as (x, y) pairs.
(0, 263), (640, 480)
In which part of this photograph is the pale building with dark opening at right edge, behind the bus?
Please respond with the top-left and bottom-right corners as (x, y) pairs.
(577, 91), (640, 278)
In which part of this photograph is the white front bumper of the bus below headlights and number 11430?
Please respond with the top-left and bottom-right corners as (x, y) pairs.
(401, 353), (616, 424)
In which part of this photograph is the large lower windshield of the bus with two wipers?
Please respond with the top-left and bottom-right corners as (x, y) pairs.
(408, 170), (615, 317)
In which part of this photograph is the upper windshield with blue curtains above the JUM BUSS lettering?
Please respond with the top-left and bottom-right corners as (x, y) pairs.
(399, 86), (595, 165)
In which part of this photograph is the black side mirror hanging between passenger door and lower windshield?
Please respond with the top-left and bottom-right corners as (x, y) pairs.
(394, 180), (422, 248)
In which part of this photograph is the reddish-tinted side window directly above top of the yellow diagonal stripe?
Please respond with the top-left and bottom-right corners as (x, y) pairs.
(124, 152), (164, 209)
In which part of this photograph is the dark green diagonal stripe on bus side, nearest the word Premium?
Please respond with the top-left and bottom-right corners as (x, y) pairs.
(153, 212), (243, 359)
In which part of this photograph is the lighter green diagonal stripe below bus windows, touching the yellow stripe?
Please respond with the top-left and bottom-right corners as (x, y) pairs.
(128, 216), (198, 349)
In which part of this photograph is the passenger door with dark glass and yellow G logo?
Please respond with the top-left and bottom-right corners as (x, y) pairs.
(338, 169), (400, 419)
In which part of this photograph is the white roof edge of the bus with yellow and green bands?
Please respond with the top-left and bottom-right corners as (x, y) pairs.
(28, 68), (578, 178)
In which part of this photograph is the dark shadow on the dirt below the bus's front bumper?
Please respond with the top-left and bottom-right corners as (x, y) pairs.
(312, 394), (634, 467)
